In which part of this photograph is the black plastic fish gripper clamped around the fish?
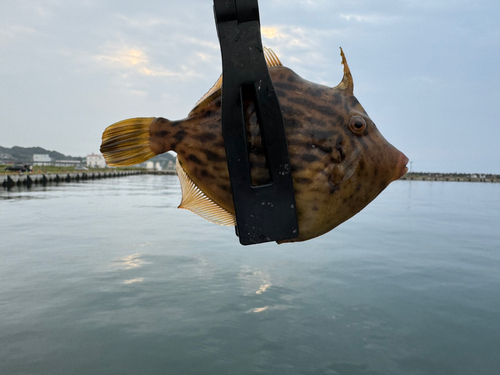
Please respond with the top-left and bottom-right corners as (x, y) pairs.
(214, 0), (299, 245)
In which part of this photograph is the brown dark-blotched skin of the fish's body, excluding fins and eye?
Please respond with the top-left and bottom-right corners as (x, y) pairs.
(144, 66), (408, 242)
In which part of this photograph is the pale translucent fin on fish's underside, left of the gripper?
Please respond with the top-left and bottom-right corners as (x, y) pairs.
(175, 158), (236, 227)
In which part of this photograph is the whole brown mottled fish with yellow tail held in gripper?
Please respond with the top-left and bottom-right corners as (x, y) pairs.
(101, 47), (408, 243)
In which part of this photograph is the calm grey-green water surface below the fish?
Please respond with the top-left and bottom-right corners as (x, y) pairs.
(0, 176), (500, 375)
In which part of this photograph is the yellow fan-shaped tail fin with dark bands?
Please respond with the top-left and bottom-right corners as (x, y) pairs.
(101, 117), (156, 167)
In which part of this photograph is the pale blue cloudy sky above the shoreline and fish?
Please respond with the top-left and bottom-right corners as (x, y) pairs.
(0, 0), (500, 174)
